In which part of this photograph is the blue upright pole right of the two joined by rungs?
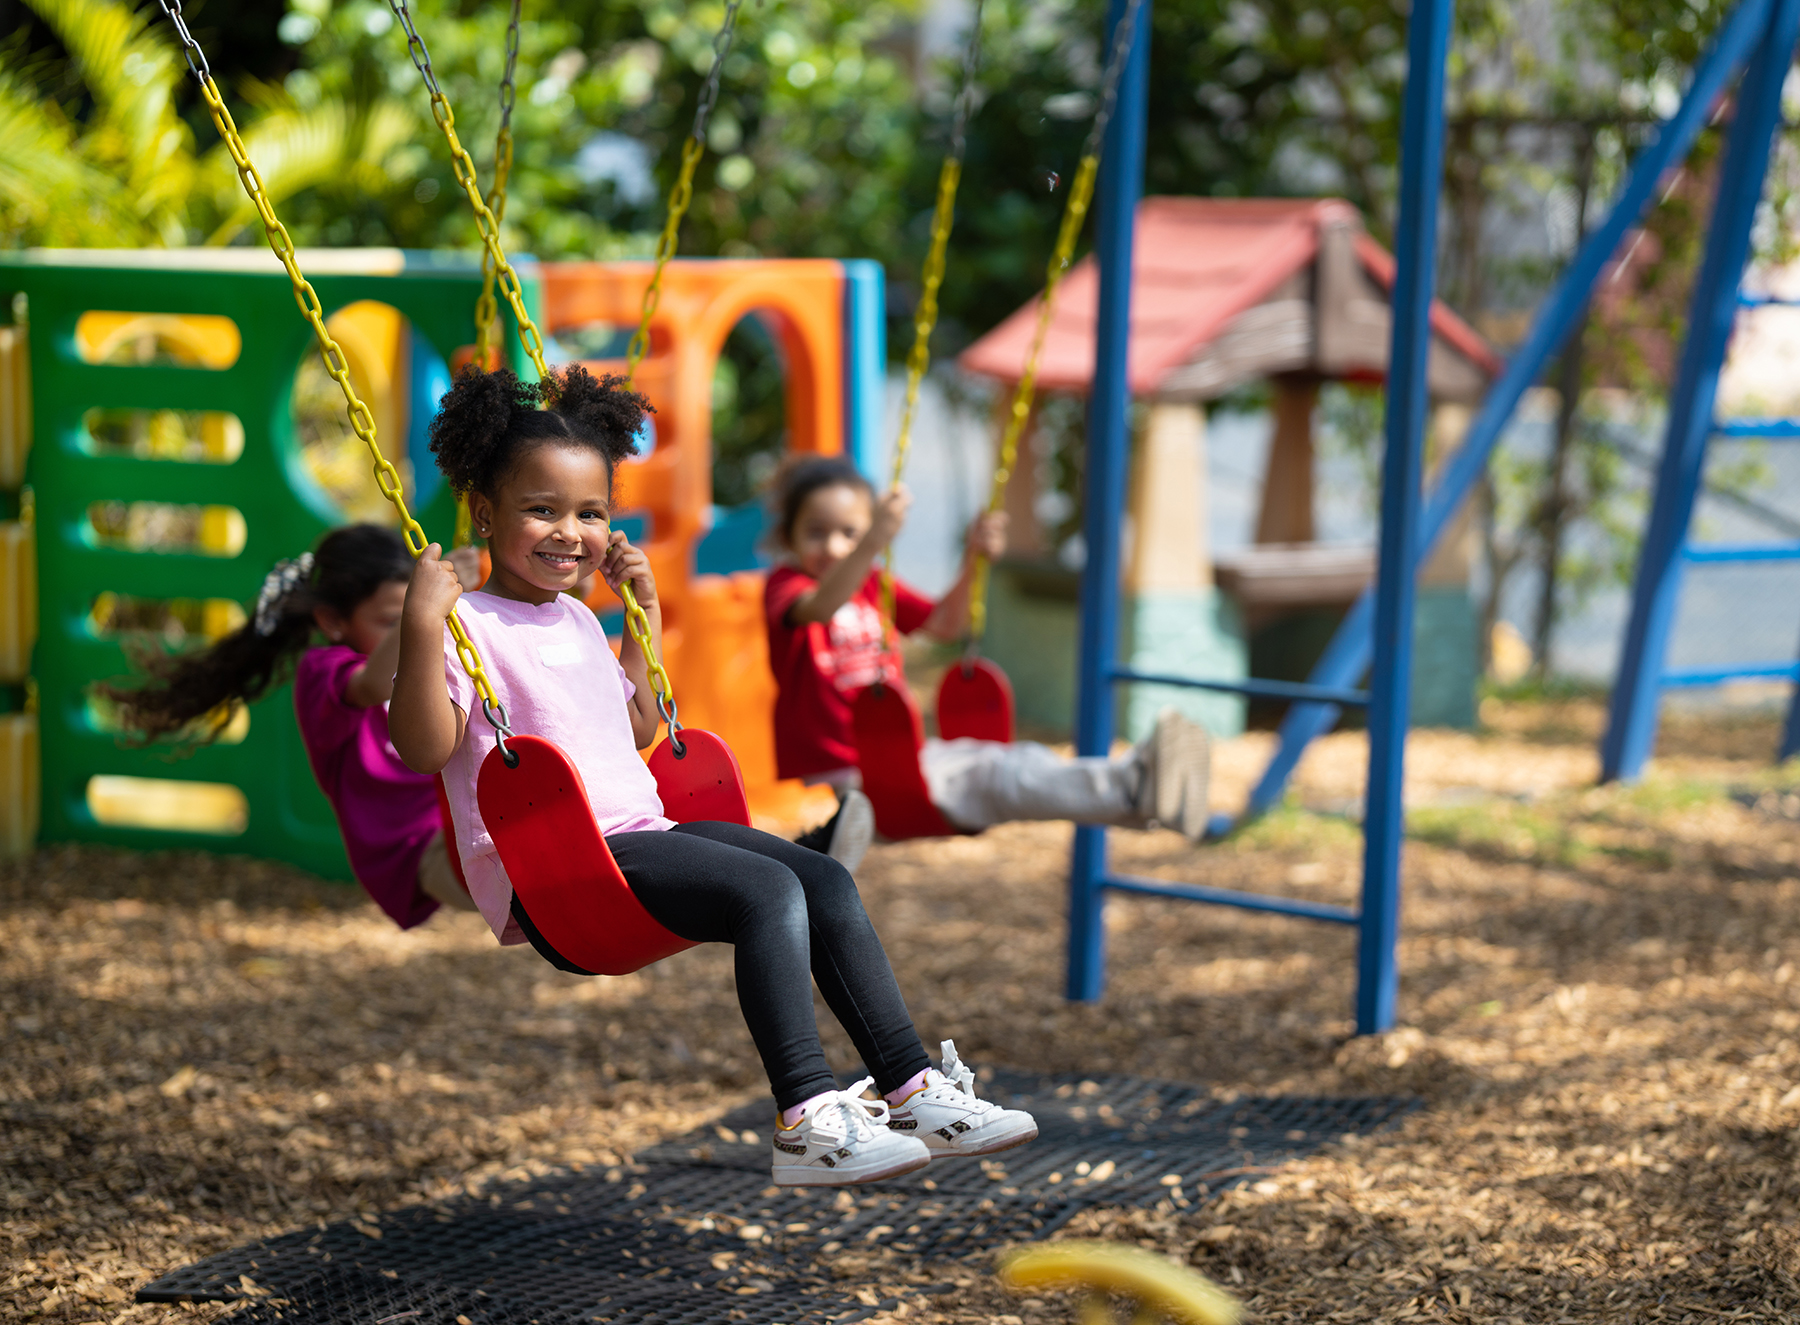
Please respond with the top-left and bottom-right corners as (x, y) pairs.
(1355, 0), (1453, 1035)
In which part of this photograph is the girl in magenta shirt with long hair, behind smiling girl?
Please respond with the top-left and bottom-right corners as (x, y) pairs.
(103, 524), (481, 929)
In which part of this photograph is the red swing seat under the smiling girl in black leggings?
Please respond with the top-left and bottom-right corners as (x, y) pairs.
(475, 729), (751, 976)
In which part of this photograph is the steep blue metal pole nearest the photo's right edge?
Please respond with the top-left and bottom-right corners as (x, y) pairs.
(1600, 0), (1800, 781)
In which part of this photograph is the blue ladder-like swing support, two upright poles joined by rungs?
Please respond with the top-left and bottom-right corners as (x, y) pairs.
(1067, 0), (1454, 1033)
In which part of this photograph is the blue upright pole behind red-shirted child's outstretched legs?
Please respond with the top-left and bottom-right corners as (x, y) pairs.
(1066, 0), (1150, 1003)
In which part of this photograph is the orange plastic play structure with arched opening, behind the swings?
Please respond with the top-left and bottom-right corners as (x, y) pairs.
(540, 259), (846, 821)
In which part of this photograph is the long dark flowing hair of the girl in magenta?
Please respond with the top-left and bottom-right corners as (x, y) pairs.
(94, 524), (412, 744)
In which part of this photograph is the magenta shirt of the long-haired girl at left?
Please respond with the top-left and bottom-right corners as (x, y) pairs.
(293, 644), (437, 929)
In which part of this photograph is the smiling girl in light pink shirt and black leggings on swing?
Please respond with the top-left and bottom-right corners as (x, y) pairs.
(389, 365), (1037, 1186)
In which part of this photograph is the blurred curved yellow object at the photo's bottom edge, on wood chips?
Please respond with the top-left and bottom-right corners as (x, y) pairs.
(1001, 1242), (1244, 1325)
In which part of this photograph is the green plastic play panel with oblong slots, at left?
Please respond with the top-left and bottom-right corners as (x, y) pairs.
(0, 250), (536, 879)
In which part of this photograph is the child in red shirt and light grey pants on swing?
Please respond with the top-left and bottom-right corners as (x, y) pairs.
(763, 455), (1210, 861)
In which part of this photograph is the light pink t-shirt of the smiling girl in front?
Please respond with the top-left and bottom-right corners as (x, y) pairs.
(443, 590), (675, 943)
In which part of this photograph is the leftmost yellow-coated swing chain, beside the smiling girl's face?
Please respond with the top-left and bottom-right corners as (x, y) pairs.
(157, 0), (511, 749)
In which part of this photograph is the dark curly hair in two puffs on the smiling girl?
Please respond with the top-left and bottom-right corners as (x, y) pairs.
(430, 364), (653, 497)
